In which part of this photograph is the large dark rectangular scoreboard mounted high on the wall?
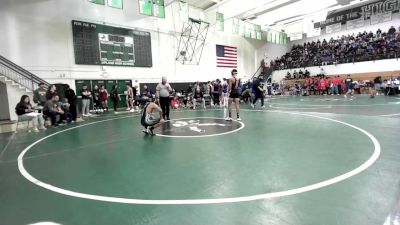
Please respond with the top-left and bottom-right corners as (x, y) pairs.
(72, 20), (153, 67)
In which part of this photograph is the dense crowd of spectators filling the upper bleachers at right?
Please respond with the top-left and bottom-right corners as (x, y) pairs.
(271, 26), (400, 70)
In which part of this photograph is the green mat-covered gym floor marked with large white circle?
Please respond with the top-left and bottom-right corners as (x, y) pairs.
(0, 96), (400, 225)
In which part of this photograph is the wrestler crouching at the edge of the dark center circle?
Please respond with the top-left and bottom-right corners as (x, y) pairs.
(140, 102), (165, 135)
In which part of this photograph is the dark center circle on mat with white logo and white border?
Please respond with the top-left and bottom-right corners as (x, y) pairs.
(157, 118), (243, 137)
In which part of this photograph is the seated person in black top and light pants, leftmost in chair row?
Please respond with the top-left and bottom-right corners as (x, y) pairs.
(15, 95), (46, 132)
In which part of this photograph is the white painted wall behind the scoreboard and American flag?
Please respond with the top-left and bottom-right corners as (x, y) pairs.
(0, 0), (265, 87)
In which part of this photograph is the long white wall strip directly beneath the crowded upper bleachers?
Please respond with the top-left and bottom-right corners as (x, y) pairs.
(272, 59), (400, 82)
